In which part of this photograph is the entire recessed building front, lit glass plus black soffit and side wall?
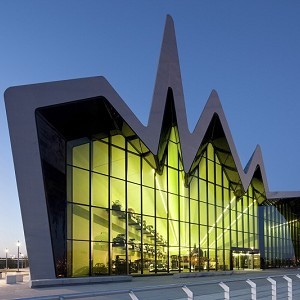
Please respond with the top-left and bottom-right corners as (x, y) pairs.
(36, 99), (300, 277)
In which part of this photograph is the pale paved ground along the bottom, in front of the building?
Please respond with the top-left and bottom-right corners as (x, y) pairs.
(0, 269), (300, 300)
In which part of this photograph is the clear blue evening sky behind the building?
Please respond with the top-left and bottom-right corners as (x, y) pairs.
(0, 0), (300, 257)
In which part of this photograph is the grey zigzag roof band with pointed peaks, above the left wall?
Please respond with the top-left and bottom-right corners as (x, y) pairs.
(5, 16), (300, 202)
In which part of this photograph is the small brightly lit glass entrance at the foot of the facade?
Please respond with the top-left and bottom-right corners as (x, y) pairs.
(231, 248), (260, 270)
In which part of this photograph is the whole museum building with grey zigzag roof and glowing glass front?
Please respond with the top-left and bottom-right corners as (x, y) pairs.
(5, 16), (300, 279)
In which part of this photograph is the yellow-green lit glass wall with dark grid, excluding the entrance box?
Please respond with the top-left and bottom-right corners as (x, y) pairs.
(67, 126), (259, 277)
